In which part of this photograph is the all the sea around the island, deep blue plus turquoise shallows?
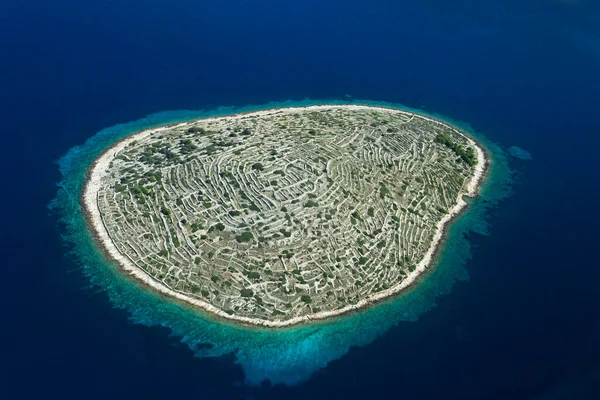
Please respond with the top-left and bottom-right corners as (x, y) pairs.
(0, 0), (600, 400)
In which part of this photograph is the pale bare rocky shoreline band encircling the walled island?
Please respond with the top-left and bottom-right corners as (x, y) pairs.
(80, 104), (489, 328)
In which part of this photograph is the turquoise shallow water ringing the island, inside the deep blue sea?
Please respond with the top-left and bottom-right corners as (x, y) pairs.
(50, 100), (512, 384)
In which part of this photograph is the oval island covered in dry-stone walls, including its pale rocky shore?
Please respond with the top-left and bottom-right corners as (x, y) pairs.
(81, 105), (488, 328)
